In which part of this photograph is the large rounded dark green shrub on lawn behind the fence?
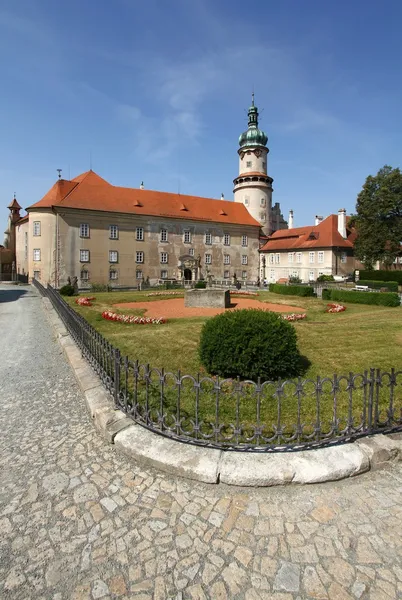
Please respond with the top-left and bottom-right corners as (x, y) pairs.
(199, 309), (301, 380)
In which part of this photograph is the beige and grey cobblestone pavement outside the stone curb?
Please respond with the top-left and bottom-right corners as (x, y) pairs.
(0, 285), (402, 600)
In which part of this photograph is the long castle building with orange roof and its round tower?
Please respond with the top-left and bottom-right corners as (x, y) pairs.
(3, 94), (287, 287)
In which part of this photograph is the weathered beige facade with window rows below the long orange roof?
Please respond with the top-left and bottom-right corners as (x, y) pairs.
(27, 209), (259, 287)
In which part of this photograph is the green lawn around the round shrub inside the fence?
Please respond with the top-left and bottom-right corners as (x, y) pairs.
(67, 292), (402, 440)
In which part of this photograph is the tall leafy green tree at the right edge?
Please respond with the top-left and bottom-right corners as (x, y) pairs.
(349, 165), (402, 269)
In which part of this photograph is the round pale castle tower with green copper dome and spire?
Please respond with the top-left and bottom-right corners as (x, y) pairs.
(233, 94), (274, 235)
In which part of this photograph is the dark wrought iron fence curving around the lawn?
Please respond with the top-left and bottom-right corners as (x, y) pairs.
(34, 281), (402, 452)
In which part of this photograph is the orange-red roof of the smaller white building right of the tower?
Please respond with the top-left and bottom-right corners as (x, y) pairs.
(261, 215), (356, 252)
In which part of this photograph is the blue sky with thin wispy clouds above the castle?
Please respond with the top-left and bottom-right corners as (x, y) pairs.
(0, 0), (402, 231)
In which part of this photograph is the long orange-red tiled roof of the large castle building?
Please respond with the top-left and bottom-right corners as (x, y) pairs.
(27, 171), (260, 227)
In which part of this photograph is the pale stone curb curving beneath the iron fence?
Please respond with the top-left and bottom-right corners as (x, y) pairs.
(42, 298), (402, 487)
